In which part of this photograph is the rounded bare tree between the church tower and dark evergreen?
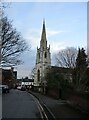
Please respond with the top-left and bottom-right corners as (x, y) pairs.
(55, 47), (77, 68)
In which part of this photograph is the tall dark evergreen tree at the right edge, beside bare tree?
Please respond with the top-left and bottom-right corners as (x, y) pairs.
(74, 48), (88, 90)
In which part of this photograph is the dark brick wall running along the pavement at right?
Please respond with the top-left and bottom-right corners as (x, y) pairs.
(47, 89), (89, 113)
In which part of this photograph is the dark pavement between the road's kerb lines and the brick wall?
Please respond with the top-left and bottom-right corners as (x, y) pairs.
(29, 91), (89, 120)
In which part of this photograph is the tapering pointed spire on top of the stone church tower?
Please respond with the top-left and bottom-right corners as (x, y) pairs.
(40, 20), (47, 48)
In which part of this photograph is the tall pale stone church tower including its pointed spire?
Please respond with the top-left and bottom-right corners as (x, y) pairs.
(34, 21), (51, 86)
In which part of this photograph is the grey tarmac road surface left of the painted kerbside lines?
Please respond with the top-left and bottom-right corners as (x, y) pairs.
(2, 89), (41, 118)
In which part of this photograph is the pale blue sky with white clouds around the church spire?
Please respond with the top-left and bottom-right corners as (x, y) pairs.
(5, 2), (87, 78)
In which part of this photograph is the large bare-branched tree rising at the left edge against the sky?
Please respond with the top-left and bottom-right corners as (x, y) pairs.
(1, 17), (27, 65)
